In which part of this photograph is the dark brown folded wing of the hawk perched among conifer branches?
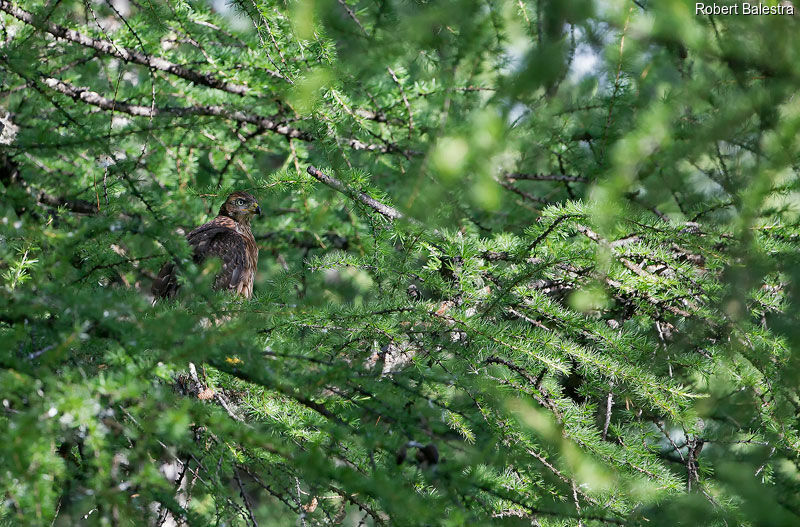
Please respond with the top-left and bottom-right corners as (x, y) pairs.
(186, 216), (252, 289)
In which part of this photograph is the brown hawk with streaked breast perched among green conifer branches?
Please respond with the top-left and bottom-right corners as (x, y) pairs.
(152, 192), (261, 299)
